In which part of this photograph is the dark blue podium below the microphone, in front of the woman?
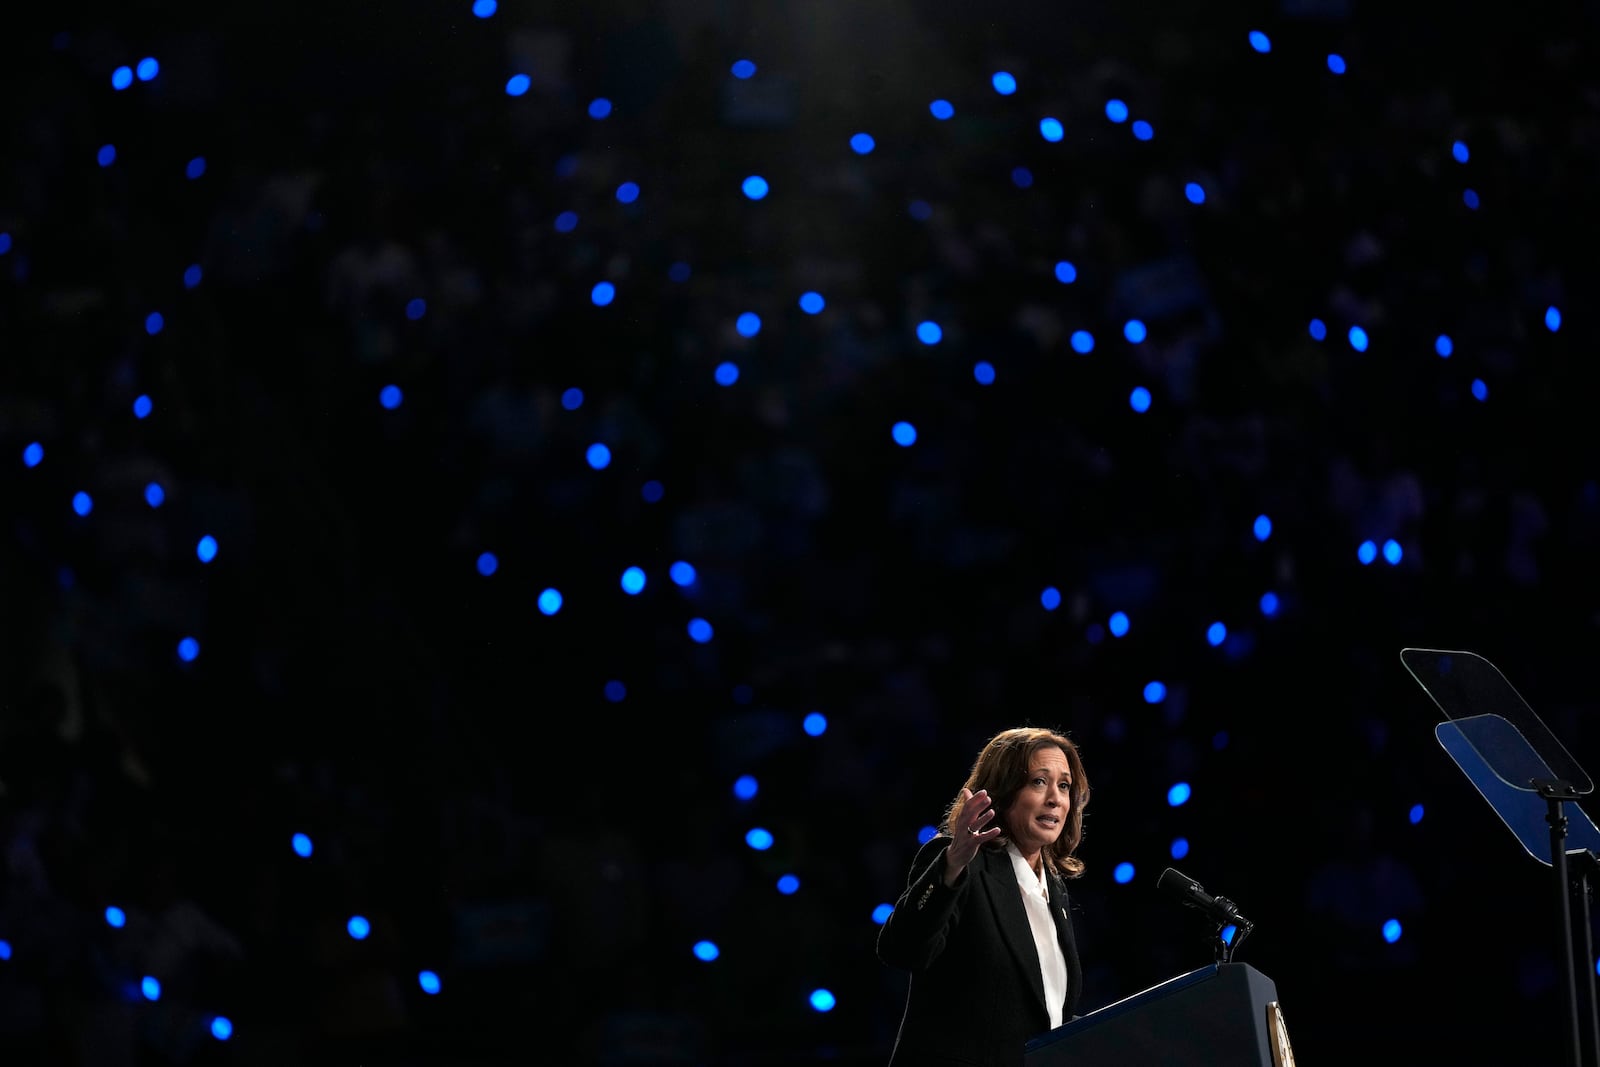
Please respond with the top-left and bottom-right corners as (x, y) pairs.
(1022, 963), (1294, 1067)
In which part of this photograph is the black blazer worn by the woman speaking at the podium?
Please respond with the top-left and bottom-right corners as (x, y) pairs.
(878, 835), (1083, 1067)
